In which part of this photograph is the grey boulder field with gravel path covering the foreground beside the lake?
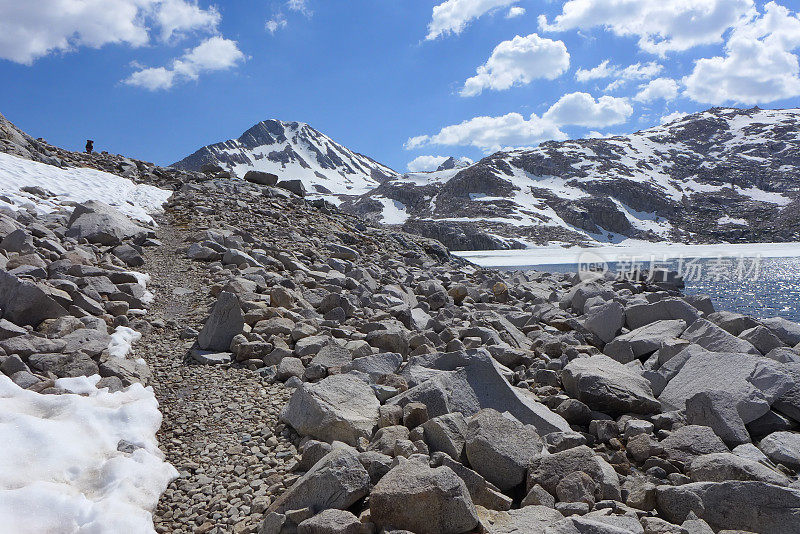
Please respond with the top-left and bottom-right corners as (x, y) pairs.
(0, 118), (800, 534)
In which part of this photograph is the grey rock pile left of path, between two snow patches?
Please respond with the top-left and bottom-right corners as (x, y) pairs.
(0, 197), (158, 393)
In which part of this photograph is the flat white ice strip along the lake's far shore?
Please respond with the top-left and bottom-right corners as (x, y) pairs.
(453, 240), (800, 267)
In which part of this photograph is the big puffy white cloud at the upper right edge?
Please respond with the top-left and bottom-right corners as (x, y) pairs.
(683, 2), (800, 105)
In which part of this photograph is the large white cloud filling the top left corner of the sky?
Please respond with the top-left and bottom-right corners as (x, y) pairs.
(0, 0), (220, 65)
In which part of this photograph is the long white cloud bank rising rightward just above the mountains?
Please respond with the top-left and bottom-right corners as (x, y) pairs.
(405, 93), (633, 152)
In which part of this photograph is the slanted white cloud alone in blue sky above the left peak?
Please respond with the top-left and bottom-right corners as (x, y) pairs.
(124, 36), (245, 91)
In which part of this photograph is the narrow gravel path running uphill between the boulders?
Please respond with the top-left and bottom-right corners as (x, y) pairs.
(136, 215), (295, 533)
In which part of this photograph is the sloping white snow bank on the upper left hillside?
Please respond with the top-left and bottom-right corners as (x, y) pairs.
(0, 152), (172, 224)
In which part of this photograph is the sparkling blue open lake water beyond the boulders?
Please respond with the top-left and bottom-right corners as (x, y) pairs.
(494, 257), (800, 322)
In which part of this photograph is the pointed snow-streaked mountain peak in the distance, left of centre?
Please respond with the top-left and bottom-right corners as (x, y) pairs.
(172, 119), (398, 195)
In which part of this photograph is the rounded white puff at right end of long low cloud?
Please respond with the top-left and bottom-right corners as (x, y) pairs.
(542, 93), (633, 128)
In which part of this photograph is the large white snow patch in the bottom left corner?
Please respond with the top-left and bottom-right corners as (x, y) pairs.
(0, 375), (178, 534)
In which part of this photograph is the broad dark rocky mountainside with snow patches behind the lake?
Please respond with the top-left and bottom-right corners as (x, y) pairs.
(342, 108), (800, 250)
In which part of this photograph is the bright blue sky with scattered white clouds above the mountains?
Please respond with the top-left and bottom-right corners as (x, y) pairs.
(0, 0), (800, 171)
